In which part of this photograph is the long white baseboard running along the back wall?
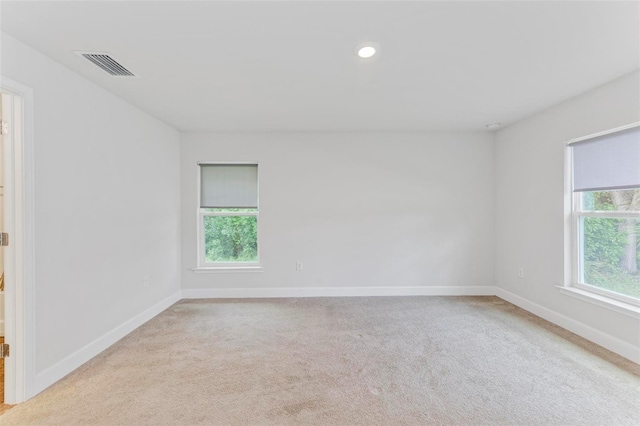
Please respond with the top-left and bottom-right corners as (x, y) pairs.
(182, 286), (496, 299)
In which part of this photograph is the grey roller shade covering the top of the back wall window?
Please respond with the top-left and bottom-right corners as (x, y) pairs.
(200, 164), (258, 208)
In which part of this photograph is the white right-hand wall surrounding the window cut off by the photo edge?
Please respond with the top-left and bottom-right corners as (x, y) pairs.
(495, 72), (640, 354)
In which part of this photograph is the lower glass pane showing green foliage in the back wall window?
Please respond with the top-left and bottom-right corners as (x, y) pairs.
(203, 216), (258, 263)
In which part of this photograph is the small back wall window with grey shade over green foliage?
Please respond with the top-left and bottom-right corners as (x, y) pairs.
(198, 164), (259, 267)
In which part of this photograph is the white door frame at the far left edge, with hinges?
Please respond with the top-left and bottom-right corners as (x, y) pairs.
(0, 75), (36, 404)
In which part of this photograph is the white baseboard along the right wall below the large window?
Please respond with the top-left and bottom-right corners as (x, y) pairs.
(495, 287), (640, 364)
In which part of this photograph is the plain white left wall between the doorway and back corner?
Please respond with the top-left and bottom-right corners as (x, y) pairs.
(0, 33), (180, 378)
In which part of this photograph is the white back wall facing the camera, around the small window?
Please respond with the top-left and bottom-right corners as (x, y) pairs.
(181, 133), (494, 295)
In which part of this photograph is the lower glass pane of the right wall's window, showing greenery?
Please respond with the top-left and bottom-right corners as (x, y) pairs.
(580, 215), (640, 298)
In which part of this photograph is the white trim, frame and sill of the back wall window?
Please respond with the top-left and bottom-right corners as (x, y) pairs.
(192, 161), (263, 273)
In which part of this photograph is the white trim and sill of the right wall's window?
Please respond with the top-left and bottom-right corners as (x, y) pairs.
(558, 122), (640, 308)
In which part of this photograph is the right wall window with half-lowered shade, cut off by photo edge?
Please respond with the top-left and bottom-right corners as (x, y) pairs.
(569, 124), (640, 305)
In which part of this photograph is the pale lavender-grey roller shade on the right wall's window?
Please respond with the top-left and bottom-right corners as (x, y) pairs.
(571, 126), (640, 192)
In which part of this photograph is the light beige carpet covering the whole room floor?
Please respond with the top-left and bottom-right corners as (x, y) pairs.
(0, 297), (640, 425)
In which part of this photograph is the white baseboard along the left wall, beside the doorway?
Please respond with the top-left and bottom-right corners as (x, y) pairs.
(34, 291), (181, 397)
